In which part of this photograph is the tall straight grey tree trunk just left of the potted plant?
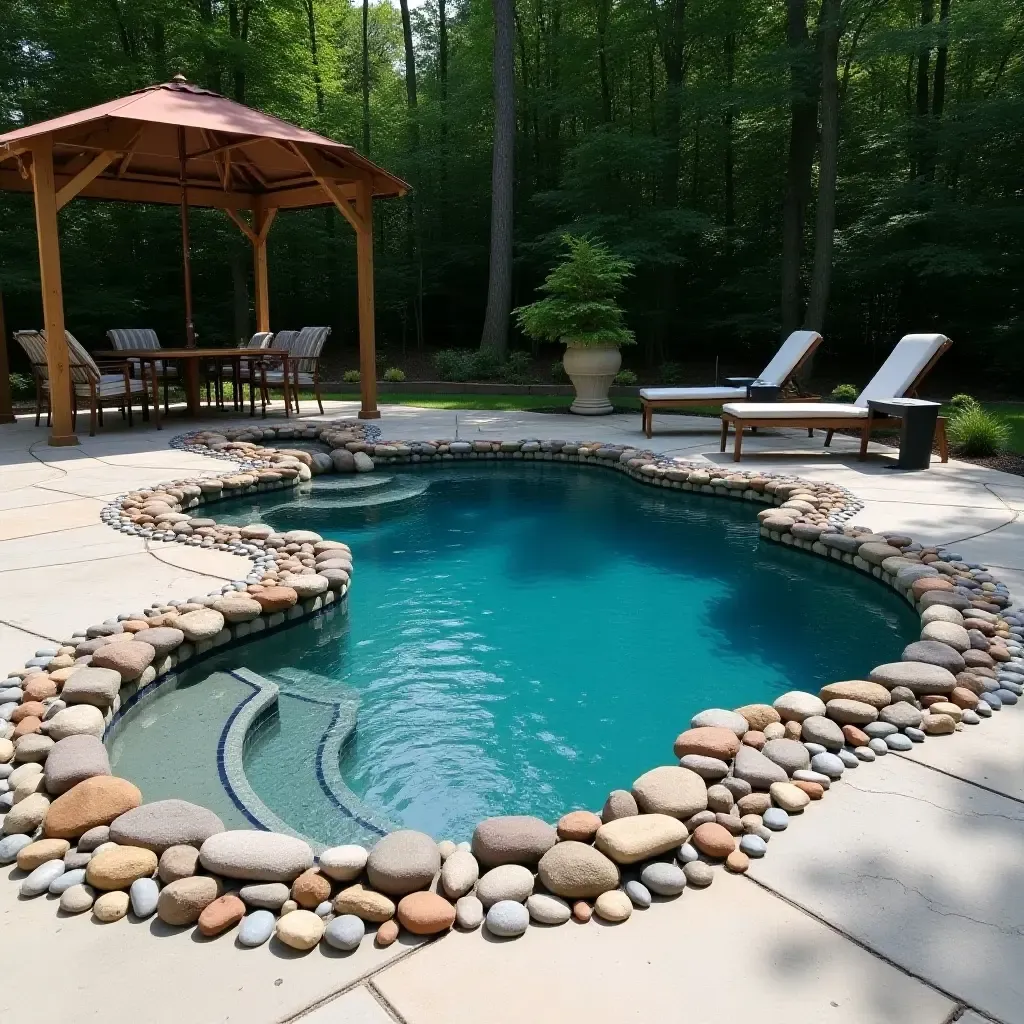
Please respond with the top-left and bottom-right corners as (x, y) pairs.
(480, 0), (515, 357)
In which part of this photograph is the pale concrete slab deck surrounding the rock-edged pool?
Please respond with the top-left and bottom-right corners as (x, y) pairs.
(0, 402), (1024, 1024)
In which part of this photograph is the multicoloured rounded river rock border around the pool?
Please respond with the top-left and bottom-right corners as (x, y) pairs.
(0, 421), (1024, 950)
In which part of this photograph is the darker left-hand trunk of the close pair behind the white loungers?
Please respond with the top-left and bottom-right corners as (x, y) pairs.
(781, 0), (818, 337)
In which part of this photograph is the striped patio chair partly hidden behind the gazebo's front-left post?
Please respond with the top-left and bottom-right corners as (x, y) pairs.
(14, 331), (150, 437)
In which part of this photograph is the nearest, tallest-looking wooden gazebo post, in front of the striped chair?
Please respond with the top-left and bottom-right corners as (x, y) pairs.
(30, 134), (78, 445)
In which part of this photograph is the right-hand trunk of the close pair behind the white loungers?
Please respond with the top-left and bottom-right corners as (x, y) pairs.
(804, 0), (843, 333)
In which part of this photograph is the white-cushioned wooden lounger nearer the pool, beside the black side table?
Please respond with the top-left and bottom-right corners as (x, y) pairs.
(721, 334), (952, 462)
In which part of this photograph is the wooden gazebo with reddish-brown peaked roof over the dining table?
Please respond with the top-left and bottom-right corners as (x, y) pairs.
(0, 76), (408, 444)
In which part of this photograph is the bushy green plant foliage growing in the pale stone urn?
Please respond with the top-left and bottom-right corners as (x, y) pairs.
(515, 234), (636, 346)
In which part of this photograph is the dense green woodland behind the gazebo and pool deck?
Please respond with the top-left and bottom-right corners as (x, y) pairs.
(0, 0), (1024, 376)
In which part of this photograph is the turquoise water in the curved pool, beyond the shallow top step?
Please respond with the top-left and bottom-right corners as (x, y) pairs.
(134, 463), (915, 842)
